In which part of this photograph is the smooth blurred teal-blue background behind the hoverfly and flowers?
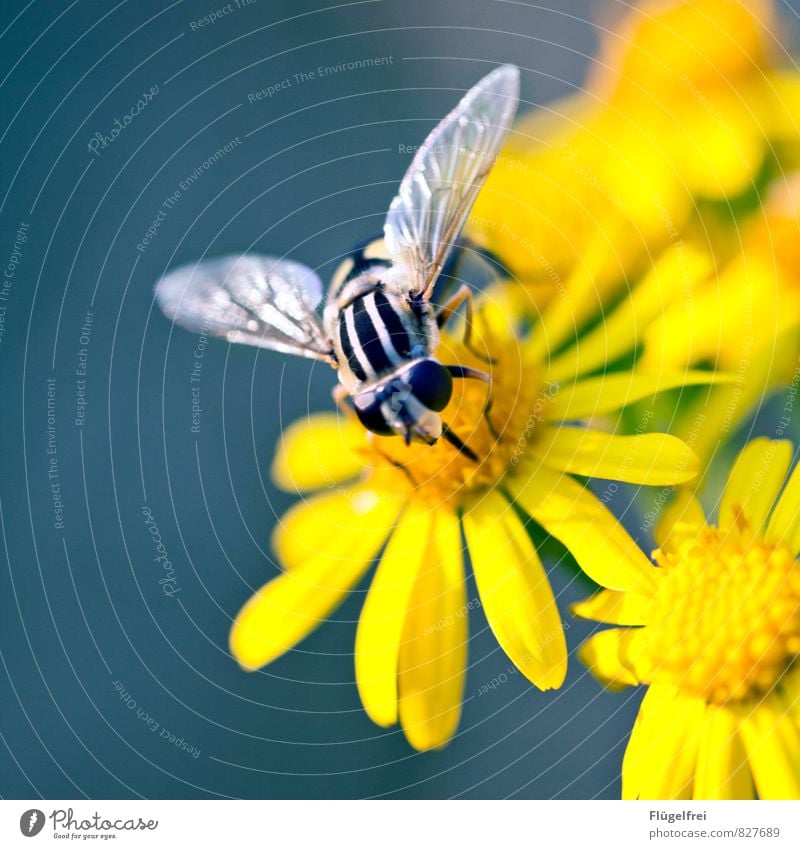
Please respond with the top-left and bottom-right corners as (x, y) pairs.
(0, 0), (792, 798)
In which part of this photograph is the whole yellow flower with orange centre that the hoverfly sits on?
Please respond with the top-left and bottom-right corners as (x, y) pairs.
(230, 286), (708, 749)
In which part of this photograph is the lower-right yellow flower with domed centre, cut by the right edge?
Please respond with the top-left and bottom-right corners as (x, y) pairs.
(575, 439), (800, 799)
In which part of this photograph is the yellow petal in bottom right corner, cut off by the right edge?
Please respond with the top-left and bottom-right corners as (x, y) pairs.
(740, 695), (800, 799)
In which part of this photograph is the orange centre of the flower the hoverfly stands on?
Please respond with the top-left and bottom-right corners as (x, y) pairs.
(363, 302), (550, 506)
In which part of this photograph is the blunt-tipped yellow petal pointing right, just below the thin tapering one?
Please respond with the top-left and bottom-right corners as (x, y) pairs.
(531, 427), (699, 486)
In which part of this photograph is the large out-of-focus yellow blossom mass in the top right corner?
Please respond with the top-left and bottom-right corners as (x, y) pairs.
(469, 0), (800, 346)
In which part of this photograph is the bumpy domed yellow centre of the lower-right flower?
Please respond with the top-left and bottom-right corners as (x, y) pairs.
(640, 525), (800, 704)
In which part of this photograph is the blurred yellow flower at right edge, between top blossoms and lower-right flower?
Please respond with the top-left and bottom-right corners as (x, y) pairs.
(550, 172), (800, 461)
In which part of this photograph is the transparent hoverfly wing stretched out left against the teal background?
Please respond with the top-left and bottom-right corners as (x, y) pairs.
(156, 254), (334, 363)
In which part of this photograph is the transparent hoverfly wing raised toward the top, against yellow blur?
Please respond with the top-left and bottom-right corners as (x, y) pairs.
(383, 65), (519, 297)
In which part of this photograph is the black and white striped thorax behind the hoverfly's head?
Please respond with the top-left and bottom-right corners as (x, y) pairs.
(337, 286), (427, 383)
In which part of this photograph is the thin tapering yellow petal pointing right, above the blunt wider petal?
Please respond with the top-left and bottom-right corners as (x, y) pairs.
(548, 371), (732, 421)
